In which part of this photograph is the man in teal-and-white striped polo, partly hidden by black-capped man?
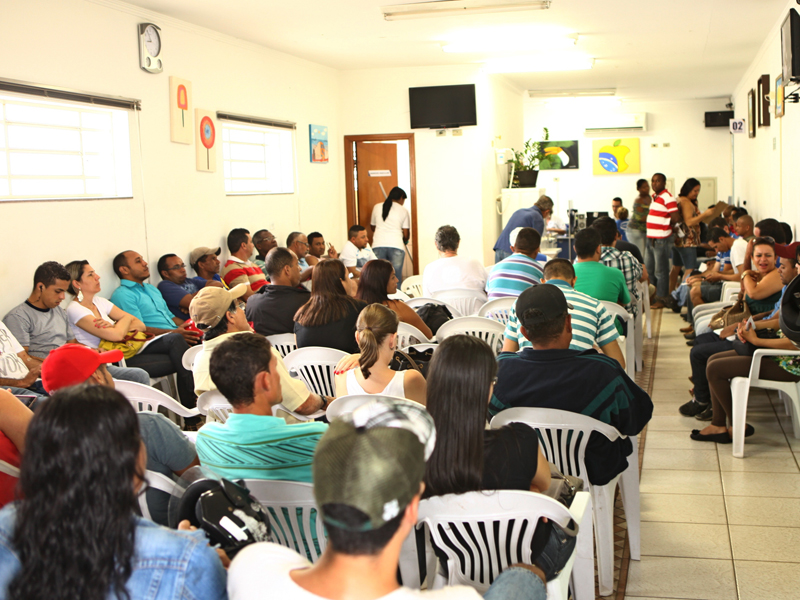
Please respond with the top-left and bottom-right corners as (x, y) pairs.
(503, 258), (625, 369)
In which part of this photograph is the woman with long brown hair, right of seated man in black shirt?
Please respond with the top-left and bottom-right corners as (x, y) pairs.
(294, 259), (367, 354)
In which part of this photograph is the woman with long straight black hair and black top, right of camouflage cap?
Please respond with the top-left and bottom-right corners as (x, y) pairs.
(424, 335), (550, 497)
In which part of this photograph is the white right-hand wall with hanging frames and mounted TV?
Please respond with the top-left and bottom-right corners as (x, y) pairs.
(733, 0), (800, 231)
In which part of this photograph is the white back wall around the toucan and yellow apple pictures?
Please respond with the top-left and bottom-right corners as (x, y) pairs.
(524, 98), (731, 218)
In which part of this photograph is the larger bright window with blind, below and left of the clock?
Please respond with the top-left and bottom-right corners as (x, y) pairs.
(0, 94), (133, 201)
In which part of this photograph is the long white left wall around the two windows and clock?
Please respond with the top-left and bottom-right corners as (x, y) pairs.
(0, 0), (340, 315)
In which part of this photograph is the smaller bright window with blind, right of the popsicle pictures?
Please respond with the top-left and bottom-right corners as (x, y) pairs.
(217, 113), (295, 195)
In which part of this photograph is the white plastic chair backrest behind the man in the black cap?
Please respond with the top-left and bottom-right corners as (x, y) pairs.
(491, 407), (625, 485)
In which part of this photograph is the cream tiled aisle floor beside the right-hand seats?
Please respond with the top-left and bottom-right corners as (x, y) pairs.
(625, 310), (800, 600)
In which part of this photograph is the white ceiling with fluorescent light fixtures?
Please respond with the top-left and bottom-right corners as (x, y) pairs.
(122, 0), (786, 99)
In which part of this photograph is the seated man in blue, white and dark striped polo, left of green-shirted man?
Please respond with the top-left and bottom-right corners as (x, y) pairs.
(486, 227), (542, 300)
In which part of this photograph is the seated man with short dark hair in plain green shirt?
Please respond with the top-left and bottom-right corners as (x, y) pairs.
(574, 227), (631, 333)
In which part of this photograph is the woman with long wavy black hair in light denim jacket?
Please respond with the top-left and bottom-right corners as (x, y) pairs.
(0, 385), (226, 600)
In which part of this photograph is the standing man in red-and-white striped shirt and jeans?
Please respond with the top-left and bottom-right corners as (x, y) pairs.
(645, 173), (678, 308)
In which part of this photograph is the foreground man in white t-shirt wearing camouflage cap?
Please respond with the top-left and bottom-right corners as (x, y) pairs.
(228, 399), (547, 600)
